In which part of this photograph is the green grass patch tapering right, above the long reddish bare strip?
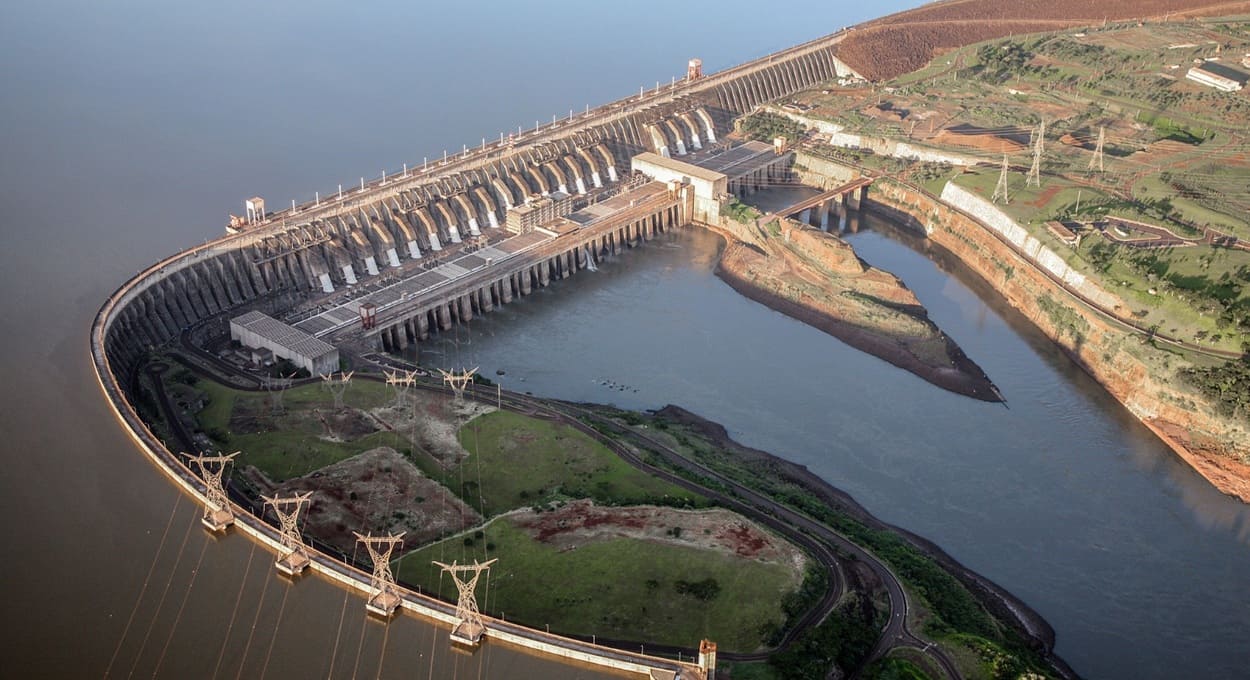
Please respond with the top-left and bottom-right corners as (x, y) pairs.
(444, 411), (705, 516)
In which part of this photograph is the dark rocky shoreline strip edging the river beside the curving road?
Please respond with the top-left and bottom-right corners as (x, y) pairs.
(651, 404), (1079, 678)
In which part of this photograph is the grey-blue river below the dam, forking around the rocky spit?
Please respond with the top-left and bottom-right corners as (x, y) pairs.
(421, 207), (1250, 679)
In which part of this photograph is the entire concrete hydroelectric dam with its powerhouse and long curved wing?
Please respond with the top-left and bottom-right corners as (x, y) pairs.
(91, 27), (858, 678)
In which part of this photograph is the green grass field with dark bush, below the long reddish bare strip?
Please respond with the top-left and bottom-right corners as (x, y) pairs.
(396, 518), (801, 651)
